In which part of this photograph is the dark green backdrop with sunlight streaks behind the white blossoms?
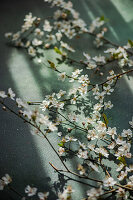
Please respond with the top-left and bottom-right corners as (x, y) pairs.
(0, 0), (133, 200)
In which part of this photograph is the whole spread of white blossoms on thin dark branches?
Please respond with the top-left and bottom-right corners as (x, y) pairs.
(0, 0), (133, 200)
